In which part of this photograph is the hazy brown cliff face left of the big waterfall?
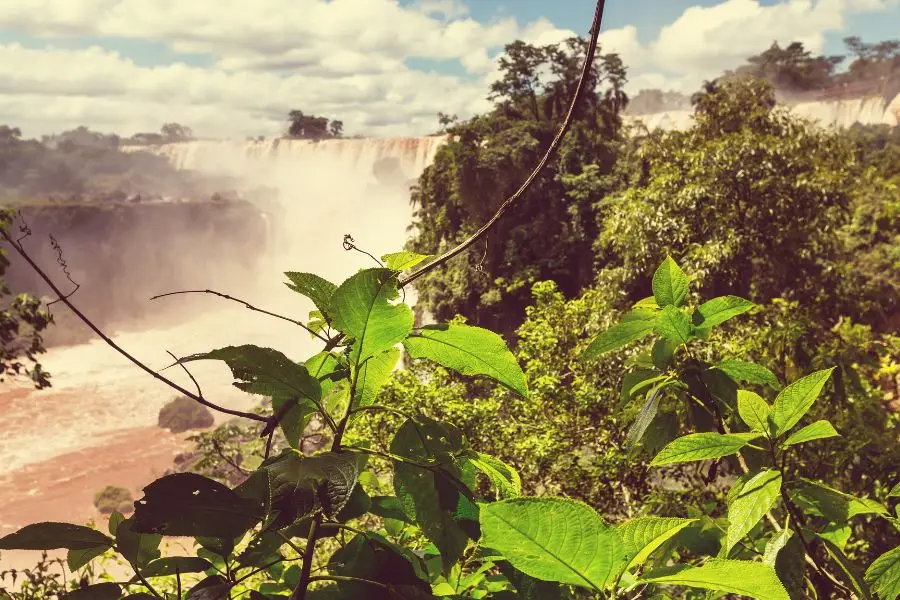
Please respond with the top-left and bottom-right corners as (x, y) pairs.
(6, 202), (269, 346)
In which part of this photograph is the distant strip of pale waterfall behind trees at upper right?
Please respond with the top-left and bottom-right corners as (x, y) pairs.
(626, 95), (900, 130)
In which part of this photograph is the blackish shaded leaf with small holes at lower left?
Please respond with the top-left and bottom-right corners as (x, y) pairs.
(132, 473), (262, 538)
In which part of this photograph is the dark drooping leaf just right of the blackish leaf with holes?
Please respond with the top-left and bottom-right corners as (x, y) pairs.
(265, 452), (360, 526)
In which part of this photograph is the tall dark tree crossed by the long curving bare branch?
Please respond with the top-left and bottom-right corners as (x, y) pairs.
(409, 38), (627, 333)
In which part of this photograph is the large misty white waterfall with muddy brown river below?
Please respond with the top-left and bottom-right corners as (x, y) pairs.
(0, 137), (444, 535)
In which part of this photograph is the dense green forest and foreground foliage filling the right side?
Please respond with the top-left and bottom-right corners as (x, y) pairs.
(0, 5), (900, 600)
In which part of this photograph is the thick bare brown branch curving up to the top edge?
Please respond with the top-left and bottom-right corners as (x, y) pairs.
(399, 0), (605, 288)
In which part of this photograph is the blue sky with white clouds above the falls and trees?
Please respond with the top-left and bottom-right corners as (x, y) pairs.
(0, 0), (900, 138)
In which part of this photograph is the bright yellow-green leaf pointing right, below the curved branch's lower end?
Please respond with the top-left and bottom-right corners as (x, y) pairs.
(403, 323), (528, 396)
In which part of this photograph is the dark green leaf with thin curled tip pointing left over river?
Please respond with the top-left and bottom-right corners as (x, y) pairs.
(178, 344), (322, 400)
